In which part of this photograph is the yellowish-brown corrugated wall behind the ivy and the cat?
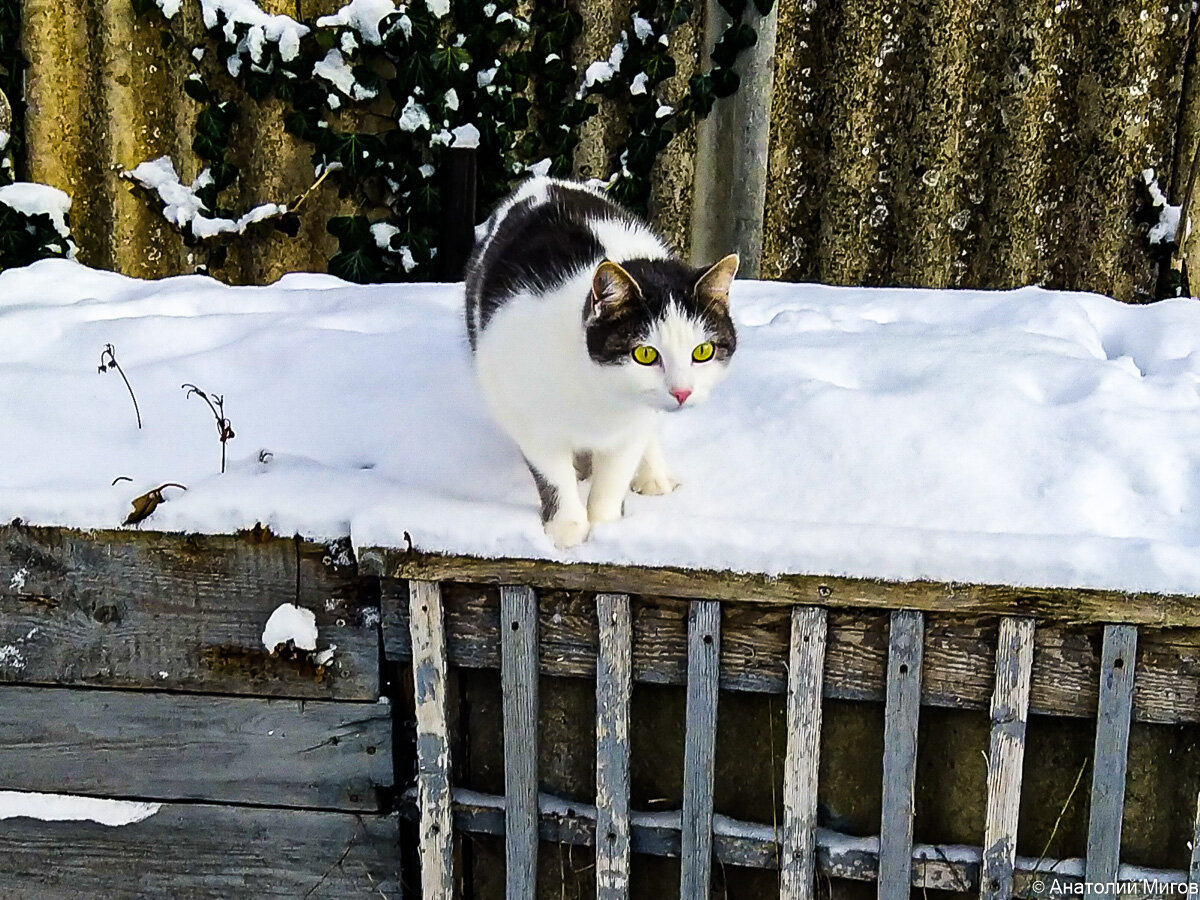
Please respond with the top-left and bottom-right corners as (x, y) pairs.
(24, 0), (1200, 300)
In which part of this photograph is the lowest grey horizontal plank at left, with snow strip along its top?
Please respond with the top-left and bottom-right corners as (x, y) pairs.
(0, 803), (403, 900)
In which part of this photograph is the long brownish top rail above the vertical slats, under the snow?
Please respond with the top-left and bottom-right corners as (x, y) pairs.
(360, 547), (1200, 628)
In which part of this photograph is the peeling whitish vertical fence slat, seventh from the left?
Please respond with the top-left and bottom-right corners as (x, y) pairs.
(979, 617), (1037, 900)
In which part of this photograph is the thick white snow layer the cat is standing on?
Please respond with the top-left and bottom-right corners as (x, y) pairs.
(0, 260), (1200, 594)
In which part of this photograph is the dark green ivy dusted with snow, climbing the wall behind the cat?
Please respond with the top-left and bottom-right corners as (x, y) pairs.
(131, 0), (773, 282)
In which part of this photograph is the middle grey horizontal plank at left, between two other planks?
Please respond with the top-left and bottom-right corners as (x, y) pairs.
(0, 685), (392, 810)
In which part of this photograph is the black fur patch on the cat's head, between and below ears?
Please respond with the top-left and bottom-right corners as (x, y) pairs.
(584, 259), (738, 366)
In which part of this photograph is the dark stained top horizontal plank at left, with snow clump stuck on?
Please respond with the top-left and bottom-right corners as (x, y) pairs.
(0, 524), (379, 701)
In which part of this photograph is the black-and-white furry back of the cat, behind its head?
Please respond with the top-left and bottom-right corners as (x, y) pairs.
(466, 178), (671, 349)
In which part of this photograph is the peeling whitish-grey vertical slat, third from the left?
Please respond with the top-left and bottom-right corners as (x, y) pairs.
(596, 594), (634, 900)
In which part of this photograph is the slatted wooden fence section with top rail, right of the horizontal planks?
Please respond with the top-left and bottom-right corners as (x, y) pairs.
(367, 552), (1200, 900)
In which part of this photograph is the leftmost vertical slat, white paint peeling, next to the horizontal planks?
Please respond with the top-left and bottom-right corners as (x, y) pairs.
(408, 581), (454, 900)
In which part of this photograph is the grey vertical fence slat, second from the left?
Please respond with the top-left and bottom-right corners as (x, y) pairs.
(500, 586), (538, 900)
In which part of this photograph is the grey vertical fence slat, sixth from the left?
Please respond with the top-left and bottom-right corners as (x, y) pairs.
(878, 610), (925, 900)
